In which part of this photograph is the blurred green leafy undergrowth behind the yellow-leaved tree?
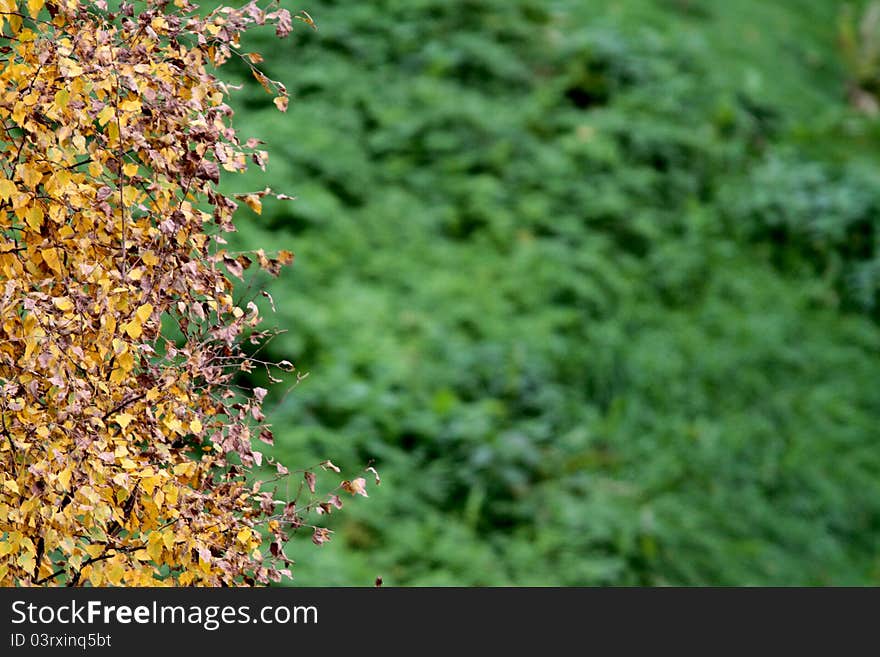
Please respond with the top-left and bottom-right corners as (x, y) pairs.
(217, 0), (880, 586)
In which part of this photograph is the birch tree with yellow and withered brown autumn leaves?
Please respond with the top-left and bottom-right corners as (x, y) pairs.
(0, 0), (366, 586)
